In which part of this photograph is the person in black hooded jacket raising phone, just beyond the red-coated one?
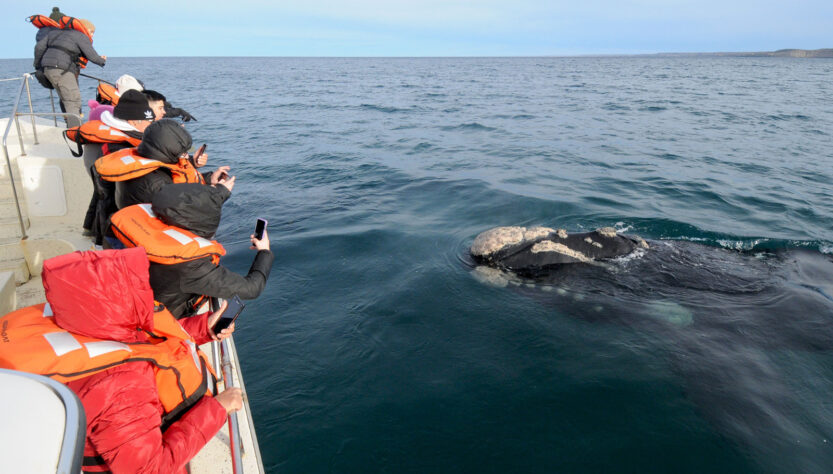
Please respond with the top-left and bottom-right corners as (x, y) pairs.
(111, 184), (275, 319)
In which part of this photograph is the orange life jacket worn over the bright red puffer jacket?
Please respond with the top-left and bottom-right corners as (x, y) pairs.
(0, 303), (215, 429)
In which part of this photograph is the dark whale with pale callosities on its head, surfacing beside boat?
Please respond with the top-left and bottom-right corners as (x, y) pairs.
(467, 226), (833, 466)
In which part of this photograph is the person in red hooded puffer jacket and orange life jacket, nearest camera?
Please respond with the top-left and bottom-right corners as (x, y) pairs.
(0, 248), (242, 473)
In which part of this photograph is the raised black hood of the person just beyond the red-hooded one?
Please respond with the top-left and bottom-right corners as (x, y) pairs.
(151, 183), (231, 239)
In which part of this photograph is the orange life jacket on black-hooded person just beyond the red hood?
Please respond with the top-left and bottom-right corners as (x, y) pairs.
(110, 204), (226, 265)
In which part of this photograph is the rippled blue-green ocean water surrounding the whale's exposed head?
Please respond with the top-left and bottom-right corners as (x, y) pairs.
(0, 57), (833, 473)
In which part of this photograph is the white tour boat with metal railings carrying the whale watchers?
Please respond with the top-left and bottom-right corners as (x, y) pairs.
(0, 74), (265, 474)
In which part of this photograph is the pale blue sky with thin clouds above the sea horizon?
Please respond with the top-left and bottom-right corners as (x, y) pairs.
(0, 0), (833, 58)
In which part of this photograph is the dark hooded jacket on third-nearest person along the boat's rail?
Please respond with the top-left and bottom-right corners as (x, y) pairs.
(116, 119), (202, 209)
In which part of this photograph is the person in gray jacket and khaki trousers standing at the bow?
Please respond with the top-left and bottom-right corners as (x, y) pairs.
(34, 20), (107, 127)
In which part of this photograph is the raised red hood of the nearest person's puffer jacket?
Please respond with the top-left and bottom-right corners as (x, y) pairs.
(42, 247), (154, 342)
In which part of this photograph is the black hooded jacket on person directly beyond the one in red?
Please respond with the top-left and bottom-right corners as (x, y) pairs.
(150, 184), (274, 318)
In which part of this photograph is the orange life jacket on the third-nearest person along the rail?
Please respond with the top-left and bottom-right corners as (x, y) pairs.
(95, 148), (205, 184)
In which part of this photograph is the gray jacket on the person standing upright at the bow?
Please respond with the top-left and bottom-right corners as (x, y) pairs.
(34, 28), (104, 74)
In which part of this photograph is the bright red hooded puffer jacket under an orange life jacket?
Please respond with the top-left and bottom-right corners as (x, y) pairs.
(43, 247), (226, 473)
